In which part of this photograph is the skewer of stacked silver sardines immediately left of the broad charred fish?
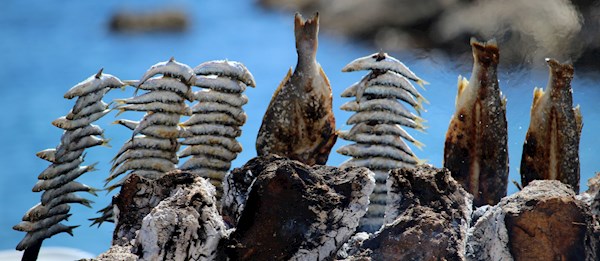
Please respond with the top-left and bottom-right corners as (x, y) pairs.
(178, 61), (256, 197)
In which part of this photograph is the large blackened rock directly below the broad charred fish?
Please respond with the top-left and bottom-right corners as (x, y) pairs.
(223, 156), (375, 260)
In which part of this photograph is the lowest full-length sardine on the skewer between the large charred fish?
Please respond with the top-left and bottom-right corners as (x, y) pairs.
(337, 144), (418, 164)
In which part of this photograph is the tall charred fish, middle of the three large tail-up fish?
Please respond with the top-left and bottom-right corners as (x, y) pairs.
(444, 38), (508, 206)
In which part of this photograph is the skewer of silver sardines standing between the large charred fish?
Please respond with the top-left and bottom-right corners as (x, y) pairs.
(337, 52), (427, 232)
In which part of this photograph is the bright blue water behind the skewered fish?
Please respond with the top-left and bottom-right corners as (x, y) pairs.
(0, 0), (600, 254)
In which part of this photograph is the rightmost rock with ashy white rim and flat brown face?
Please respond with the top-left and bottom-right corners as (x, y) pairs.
(467, 180), (598, 260)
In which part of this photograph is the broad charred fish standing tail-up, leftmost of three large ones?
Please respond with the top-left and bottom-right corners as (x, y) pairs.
(256, 13), (337, 165)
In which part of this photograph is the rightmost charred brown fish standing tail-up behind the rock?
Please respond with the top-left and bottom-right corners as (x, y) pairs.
(519, 59), (583, 193)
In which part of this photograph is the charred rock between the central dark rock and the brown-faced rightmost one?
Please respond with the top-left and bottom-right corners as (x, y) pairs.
(350, 165), (472, 260)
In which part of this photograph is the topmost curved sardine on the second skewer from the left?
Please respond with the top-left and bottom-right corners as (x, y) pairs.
(138, 57), (196, 87)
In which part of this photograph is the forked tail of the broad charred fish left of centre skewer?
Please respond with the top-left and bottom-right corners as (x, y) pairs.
(294, 12), (319, 54)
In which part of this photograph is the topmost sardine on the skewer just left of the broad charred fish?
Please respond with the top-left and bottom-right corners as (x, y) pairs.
(194, 60), (256, 87)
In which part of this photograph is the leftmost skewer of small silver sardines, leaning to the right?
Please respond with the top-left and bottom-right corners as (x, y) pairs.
(13, 70), (125, 250)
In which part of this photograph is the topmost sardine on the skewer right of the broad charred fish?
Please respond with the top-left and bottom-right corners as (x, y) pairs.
(342, 51), (429, 87)
